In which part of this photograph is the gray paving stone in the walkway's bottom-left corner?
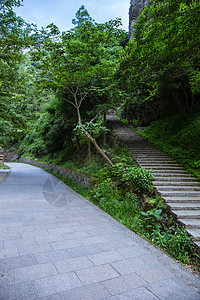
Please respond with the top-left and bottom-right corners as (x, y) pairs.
(0, 282), (38, 300)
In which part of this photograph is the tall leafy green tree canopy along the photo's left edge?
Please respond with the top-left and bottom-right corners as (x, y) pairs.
(0, 0), (30, 145)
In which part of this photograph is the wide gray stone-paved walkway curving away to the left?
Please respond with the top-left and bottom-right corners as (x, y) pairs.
(0, 163), (200, 300)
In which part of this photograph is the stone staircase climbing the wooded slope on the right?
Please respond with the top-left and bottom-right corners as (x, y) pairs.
(107, 115), (200, 247)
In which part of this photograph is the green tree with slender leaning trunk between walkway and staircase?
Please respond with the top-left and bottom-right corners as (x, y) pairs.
(33, 7), (124, 164)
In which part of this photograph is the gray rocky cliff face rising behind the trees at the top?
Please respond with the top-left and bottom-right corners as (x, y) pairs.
(129, 0), (151, 39)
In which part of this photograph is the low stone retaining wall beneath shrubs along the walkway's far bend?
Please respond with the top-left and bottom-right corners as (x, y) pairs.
(18, 157), (92, 188)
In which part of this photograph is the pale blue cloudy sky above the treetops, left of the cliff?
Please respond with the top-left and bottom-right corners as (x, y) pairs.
(15, 0), (130, 31)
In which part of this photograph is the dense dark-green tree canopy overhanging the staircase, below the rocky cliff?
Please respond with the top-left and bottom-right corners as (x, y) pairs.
(118, 0), (200, 122)
